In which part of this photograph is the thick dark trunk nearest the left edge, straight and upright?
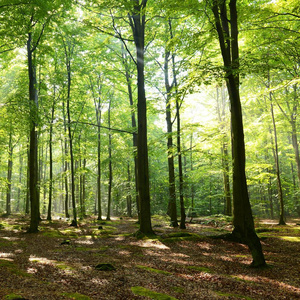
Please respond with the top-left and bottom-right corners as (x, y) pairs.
(27, 33), (40, 233)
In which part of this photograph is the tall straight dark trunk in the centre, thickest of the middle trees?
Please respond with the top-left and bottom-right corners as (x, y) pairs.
(129, 0), (153, 234)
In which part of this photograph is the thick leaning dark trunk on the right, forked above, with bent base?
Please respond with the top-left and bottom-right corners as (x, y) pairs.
(212, 0), (266, 267)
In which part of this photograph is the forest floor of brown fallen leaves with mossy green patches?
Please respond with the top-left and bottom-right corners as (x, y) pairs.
(0, 216), (300, 300)
